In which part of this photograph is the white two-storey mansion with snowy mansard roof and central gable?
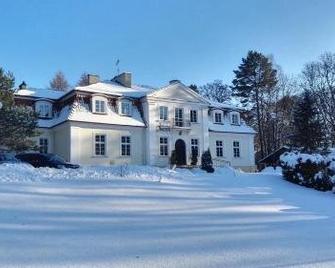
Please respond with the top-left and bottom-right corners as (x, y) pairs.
(15, 73), (255, 171)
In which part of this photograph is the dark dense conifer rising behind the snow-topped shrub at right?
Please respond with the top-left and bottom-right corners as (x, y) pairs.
(293, 90), (323, 151)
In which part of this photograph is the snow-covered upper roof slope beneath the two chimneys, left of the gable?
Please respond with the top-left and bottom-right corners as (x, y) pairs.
(75, 81), (155, 98)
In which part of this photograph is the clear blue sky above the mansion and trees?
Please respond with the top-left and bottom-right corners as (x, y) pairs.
(0, 0), (335, 87)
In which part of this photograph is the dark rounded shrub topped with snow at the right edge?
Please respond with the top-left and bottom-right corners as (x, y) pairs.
(280, 152), (333, 191)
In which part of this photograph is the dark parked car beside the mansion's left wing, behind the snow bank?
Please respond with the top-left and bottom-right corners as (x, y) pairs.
(16, 153), (79, 168)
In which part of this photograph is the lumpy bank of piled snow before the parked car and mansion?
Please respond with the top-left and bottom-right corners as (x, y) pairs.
(0, 164), (189, 183)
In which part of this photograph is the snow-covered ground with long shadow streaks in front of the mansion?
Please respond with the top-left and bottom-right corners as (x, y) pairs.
(0, 165), (335, 268)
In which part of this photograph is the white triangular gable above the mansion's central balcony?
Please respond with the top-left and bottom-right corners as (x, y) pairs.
(148, 83), (208, 104)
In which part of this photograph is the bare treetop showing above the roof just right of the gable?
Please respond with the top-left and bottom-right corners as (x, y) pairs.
(200, 80), (232, 102)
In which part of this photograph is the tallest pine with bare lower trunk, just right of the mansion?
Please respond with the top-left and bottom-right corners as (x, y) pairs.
(232, 51), (277, 158)
